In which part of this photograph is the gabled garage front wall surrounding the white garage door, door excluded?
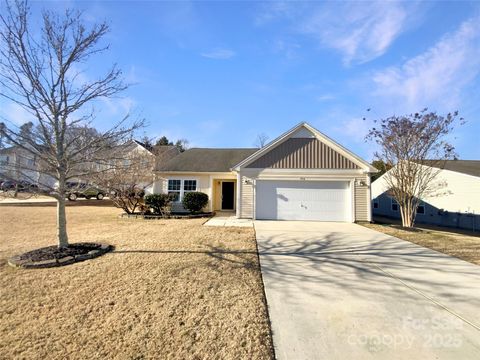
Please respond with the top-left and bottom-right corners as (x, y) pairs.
(235, 124), (375, 221)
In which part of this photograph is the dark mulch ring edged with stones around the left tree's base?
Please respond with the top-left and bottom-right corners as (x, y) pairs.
(8, 243), (113, 269)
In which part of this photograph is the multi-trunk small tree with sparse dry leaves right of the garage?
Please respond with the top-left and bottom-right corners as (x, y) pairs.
(366, 109), (463, 227)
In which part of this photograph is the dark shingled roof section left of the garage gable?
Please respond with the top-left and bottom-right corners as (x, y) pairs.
(157, 148), (258, 172)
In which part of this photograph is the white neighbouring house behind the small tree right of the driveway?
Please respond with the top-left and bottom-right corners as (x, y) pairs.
(372, 160), (480, 231)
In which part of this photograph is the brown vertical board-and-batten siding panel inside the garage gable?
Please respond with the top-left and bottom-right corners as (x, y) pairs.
(247, 138), (359, 169)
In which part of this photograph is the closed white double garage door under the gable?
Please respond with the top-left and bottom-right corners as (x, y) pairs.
(256, 180), (352, 221)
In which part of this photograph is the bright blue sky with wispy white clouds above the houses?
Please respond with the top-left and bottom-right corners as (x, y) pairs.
(0, 1), (480, 160)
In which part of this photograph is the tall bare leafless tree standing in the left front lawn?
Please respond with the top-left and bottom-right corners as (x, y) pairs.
(0, 0), (142, 247)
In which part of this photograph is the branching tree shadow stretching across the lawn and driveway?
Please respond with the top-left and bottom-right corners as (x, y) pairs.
(112, 232), (480, 307)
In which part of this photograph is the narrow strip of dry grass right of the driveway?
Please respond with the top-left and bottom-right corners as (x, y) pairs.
(361, 220), (480, 265)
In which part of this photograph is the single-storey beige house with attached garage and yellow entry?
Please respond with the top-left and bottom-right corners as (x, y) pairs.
(154, 123), (377, 222)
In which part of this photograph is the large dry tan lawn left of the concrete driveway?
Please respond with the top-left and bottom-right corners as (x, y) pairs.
(0, 207), (272, 359)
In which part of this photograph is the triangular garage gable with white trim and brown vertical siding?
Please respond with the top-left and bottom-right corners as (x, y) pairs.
(234, 123), (378, 172)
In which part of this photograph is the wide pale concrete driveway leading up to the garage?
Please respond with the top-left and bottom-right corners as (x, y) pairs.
(255, 221), (480, 360)
